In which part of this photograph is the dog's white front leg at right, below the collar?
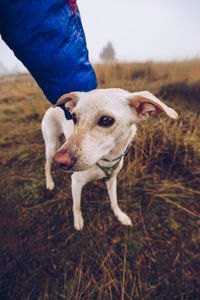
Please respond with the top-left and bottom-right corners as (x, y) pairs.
(106, 176), (132, 226)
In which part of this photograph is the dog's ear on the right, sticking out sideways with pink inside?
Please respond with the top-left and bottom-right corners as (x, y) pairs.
(128, 91), (178, 120)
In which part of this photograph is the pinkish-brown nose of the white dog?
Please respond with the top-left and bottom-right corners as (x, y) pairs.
(53, 151), (75, 170)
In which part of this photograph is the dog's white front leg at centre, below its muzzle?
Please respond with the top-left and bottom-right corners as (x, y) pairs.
(71, 173), (86, 230)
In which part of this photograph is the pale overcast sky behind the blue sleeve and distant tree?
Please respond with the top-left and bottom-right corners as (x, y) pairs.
(0, 0), (200, 70)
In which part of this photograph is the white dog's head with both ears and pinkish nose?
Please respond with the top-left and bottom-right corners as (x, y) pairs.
(54, 89), (178, 172)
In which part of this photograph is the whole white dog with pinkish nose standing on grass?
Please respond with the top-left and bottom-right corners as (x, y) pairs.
(42, 89), (178, 230)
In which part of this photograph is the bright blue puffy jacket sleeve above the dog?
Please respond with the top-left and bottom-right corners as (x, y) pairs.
(0, 0), (97, 104)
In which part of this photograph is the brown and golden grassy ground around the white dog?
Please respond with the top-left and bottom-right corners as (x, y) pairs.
(0, 60), (200, 300)
